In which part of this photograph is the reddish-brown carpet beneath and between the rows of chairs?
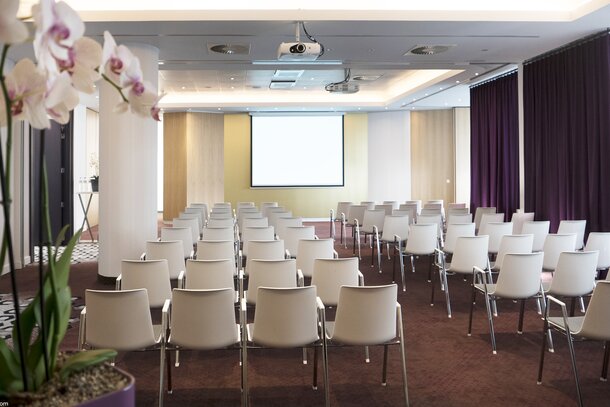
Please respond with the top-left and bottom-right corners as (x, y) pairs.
(0, 223), (610, 407)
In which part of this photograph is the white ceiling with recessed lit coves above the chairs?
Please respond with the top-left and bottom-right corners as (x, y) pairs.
(10, 0), (610, 111)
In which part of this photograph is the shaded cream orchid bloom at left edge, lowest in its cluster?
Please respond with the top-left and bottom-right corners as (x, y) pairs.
(0, 59), (50, 129)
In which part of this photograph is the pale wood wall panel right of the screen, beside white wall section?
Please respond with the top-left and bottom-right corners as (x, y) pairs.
(411, 109), (455, 203)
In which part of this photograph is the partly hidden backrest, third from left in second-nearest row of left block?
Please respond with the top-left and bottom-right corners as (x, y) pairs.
(246, 259), (297, 304)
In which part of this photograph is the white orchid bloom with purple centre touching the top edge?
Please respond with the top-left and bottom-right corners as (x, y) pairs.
(32, 0), (85, 74)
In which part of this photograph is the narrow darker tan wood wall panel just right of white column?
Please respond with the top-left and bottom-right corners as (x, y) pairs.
(163, 113), (187, 221)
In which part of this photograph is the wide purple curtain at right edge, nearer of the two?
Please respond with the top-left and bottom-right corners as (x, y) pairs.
(523, 33), (610, 231)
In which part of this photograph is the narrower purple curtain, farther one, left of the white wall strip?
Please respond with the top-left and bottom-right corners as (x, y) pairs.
(470, 72), (519, 220)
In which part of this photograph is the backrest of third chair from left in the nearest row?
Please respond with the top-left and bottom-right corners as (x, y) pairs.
(252, 286), (319, 348)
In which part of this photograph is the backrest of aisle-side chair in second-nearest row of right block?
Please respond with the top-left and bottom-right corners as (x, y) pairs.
(495, 252), (544, 299)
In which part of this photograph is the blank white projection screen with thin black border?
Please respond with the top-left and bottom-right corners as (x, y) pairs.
(250, 114), (344, 188)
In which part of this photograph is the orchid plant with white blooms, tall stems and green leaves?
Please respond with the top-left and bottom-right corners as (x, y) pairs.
(0, 0), (162, 397)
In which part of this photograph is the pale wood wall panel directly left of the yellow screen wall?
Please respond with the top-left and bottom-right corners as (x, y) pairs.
(186, 113), (224, 204)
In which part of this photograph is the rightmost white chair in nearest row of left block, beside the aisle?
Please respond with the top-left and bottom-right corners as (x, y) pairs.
(326, 284), (409, 406)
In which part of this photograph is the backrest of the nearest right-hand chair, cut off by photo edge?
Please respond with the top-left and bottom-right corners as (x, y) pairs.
(579, 281), (610, 341)
